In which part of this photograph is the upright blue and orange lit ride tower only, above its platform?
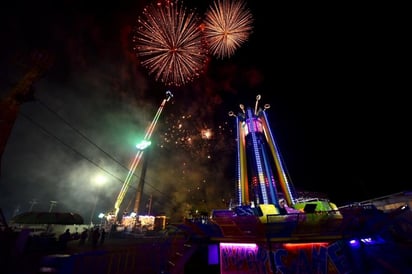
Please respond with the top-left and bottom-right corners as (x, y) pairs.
(229, 95), (297, 211)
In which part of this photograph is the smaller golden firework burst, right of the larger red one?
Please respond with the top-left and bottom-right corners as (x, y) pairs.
(204, 0), (253, 59)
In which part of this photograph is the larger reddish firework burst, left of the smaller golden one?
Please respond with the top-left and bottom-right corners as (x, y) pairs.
(132, 0), (207, 86)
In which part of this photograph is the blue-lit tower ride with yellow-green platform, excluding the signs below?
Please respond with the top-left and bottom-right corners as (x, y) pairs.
(199, 95), (343, 241)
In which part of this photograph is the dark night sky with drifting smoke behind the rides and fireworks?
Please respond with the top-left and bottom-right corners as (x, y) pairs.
(0, 1), (412, 223)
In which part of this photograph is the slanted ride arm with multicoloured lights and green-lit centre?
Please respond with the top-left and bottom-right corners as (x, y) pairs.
(108, 90), (173, 223)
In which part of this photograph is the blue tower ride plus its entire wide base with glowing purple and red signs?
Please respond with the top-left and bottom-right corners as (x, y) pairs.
(174, 96), (412, 274)
